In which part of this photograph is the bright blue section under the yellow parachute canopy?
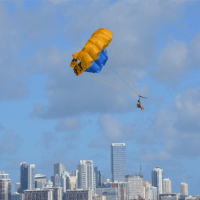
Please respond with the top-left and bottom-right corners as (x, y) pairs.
(85, 50), (108, 73)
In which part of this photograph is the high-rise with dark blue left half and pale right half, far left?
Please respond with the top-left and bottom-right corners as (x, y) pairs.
(20, 162), (35, 193)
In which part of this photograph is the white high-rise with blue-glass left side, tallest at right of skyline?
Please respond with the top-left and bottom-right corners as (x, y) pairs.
(151, 167), (163, 194)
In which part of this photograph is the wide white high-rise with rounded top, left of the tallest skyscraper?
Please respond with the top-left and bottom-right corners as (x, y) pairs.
(77, 160), (96, 192)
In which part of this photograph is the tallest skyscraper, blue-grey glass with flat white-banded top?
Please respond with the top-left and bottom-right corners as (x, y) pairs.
(111, 143), (126, 182)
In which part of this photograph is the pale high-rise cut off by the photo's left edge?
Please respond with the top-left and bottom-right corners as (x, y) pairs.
(0, 171), (11, 200)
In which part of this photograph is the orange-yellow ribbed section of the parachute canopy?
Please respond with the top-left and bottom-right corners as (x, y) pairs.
(70, 28), (113, 76)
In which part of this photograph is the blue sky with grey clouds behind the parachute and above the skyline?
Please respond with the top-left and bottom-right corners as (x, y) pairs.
(0, 0), (200, 195)
